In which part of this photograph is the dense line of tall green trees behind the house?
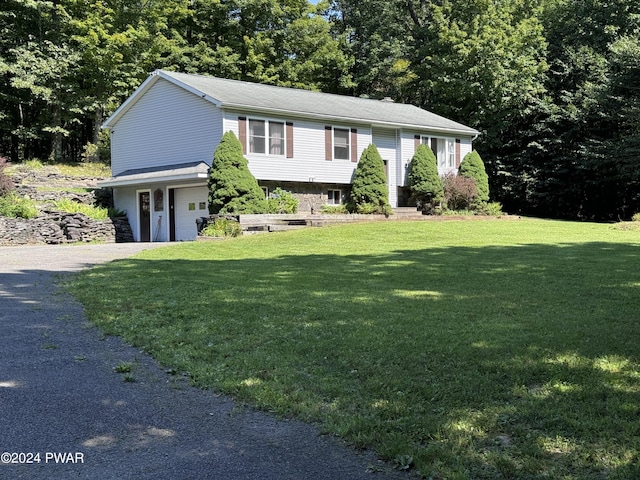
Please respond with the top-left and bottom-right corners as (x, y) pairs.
(0, 0), (640, 220)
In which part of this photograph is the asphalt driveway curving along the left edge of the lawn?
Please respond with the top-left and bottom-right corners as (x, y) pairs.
(0, 244), (406, 480)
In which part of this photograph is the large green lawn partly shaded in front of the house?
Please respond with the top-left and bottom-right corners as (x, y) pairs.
(65, 220), (640, 479)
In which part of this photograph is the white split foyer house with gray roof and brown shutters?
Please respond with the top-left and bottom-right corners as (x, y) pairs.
(99, 70), (478, 242)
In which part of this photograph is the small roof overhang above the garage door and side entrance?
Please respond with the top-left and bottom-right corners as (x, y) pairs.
(98, 162), (209, 187)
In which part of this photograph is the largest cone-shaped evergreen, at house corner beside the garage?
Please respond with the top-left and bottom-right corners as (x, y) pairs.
(209, 131), (267, 214)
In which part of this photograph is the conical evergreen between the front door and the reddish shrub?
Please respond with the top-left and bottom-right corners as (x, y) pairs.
(409, 145), (444, 211)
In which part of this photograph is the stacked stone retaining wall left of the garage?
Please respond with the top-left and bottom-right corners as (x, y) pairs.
(0, 211), (133, 245)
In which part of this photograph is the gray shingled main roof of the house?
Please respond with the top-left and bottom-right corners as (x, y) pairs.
(152, 70), (478, 135)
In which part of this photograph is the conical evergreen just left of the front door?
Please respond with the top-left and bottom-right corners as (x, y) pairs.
(350, 144), (391, 215)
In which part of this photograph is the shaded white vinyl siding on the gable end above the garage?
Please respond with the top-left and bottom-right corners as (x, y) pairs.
(111, 80), (222, 175)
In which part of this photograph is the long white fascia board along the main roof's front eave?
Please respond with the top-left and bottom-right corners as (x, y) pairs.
(222, 103), (480, 137)
